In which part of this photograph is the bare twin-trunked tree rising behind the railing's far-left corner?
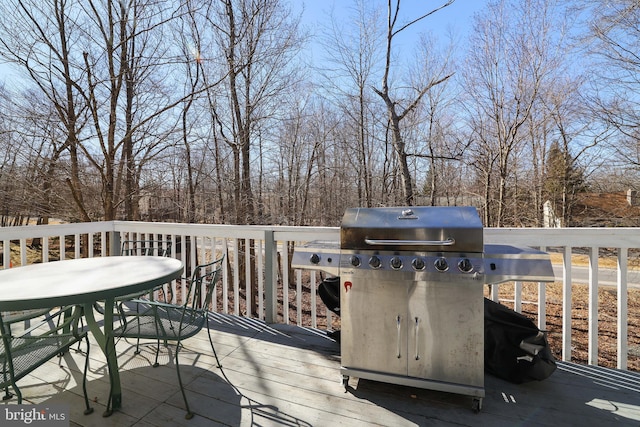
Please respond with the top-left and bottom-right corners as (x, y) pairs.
(81, 0), (184, 219)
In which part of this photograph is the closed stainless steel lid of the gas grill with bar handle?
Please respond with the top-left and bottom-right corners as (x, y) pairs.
(340, 206), (483, 252)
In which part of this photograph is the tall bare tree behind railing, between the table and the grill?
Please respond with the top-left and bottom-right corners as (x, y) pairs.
(208, 0), (301, 224)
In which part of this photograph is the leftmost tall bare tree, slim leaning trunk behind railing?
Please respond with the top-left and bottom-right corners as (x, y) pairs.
(0, 0), (94, 220)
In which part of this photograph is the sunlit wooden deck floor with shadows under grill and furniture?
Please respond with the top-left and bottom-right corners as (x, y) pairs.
(3, 315), (640, 427)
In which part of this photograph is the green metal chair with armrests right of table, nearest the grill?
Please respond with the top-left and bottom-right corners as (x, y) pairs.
(112, 257), (224, 419)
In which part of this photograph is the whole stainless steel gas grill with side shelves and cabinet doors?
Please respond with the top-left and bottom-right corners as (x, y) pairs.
(292, 207), (554, 411)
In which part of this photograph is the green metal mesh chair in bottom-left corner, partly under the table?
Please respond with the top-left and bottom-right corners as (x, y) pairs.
(0, 307), (93, 414)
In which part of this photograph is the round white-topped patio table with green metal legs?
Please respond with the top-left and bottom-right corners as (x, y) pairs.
(0, 256), (183, 416)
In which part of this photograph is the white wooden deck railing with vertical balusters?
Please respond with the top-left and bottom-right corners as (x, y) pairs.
(0, 221), (640, 369)
